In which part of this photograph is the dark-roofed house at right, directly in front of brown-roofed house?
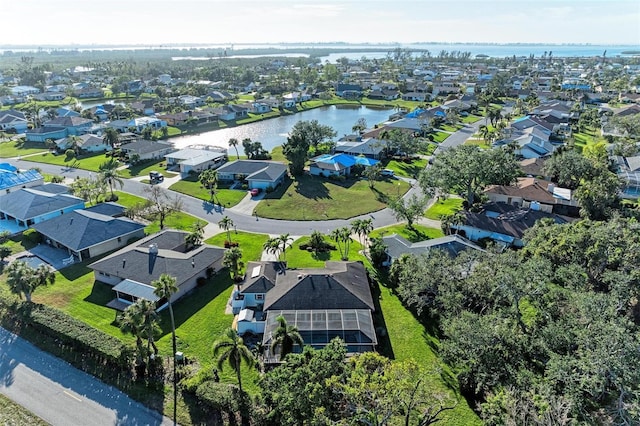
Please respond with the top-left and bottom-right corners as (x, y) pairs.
(451, 203), (567, 247)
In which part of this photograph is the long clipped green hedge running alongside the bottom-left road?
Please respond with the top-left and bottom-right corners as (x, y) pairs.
(20, 303), (132, 368)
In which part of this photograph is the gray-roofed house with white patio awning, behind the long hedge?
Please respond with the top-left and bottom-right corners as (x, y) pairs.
(89, 230), (224, 310)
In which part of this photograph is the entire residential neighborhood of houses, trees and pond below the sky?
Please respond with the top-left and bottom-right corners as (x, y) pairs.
(0, 3), (640, 425)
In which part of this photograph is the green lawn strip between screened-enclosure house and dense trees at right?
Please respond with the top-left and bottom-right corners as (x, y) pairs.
(376, 286), (481, 426)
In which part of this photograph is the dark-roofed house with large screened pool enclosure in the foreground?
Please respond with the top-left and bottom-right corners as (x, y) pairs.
(232, 262), (377, 362)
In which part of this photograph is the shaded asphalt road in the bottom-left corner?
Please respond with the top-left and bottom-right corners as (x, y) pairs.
(0, 327), (173, 426)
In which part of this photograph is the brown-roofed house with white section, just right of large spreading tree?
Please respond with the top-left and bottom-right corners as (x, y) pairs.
(484, 178), (580, 216)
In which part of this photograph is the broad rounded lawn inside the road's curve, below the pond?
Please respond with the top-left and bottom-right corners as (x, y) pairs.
(255, 175), (409, 220)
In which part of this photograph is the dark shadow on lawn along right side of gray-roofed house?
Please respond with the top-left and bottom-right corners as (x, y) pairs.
(160, 269), (233, 336)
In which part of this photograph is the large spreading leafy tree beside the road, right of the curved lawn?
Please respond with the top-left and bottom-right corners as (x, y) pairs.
(419, 145), (520, 208)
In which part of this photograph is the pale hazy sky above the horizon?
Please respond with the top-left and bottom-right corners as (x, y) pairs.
(5, 0), (640, 46)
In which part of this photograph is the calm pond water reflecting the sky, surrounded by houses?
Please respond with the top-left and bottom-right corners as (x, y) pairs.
(170, 105), (394, 155)
